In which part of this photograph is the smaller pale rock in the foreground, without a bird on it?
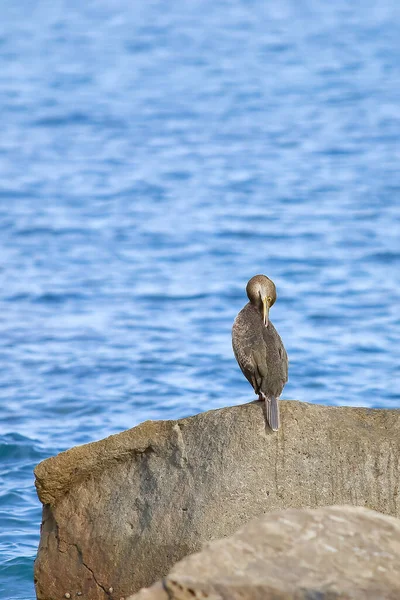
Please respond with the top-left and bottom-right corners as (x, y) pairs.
(127, 506), (400, 600)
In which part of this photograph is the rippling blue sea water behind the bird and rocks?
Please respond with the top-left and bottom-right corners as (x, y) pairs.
(0, 0), (400, 600)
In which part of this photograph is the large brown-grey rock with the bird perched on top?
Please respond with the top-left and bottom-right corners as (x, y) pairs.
(35, 401), (400, 600)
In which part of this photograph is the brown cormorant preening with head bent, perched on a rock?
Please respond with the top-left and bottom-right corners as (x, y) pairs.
(232, 275), (288, 431)
